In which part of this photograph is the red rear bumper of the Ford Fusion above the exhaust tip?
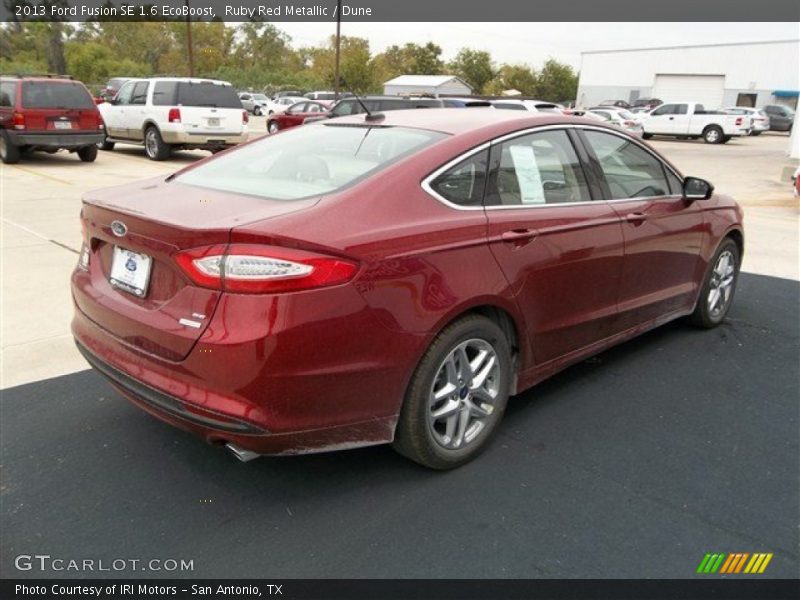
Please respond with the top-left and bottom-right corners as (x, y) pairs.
(72, 286), (424, 454)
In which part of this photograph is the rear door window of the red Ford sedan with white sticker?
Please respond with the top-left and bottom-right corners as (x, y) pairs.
(486, 129), (592, 206)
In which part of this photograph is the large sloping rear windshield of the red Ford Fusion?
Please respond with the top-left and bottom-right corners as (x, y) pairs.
(176, 123), (447, 200)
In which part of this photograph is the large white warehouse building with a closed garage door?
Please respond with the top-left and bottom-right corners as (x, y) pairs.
(577, 40), (800, 109)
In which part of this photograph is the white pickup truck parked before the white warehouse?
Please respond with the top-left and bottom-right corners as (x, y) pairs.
(642, 102), (751, 144)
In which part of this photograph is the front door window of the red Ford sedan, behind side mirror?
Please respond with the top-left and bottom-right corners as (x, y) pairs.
(583, 130), (670, 200)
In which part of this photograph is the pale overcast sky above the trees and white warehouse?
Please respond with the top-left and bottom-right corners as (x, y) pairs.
(274, 22), (800, 69)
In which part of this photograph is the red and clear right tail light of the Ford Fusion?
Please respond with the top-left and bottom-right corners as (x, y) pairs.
(175, 244), (358, 294)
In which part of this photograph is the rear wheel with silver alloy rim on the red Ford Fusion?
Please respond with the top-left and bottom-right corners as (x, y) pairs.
(393, 315), (511, 470)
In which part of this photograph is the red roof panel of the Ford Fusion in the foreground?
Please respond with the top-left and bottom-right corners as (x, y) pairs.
(326, 108), (586, 135)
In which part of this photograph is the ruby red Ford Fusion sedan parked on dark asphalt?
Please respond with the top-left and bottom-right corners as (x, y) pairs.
(72, 109), (743, 469)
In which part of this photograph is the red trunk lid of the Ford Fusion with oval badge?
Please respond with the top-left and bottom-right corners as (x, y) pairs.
(73, 180), (316, 361)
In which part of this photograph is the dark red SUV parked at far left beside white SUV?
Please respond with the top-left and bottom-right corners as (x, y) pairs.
(0, 76), (104, 165)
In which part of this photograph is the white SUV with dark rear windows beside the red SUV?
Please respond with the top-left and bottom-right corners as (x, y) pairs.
(98, 77), (249, 160)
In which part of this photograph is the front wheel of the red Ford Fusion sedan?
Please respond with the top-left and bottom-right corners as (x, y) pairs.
(690, 238), (741, 329)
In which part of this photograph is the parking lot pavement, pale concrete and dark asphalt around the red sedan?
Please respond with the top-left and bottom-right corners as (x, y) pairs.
(0, 119), (800, 578)
